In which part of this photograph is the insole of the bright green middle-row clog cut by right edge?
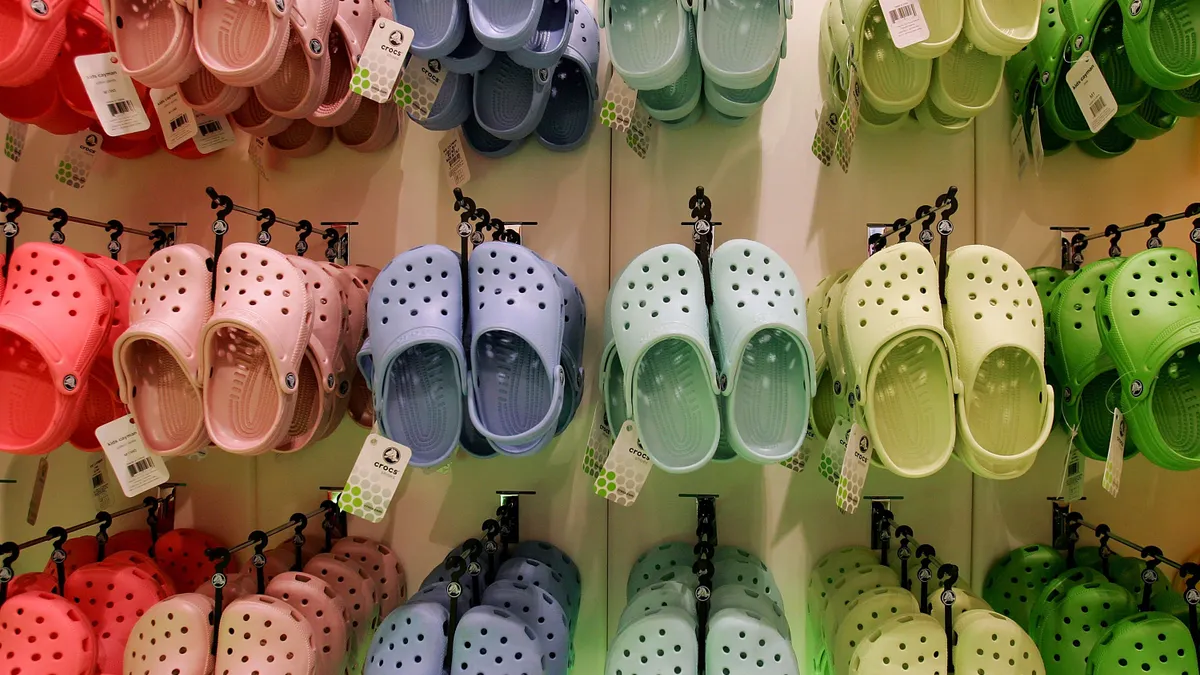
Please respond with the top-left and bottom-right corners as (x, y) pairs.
(1147, 344), (1200, 458)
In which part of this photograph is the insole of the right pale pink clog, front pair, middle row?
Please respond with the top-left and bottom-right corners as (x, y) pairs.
(205, 325), (284, 449)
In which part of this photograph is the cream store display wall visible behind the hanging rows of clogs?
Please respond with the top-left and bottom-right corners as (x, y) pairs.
(0, 4), (1200, 674)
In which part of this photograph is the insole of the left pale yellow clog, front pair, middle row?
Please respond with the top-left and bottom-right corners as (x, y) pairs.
(864, 330), (955, 467)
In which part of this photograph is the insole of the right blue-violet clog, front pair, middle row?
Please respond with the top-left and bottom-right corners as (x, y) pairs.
(472, 330), (554, 436)
